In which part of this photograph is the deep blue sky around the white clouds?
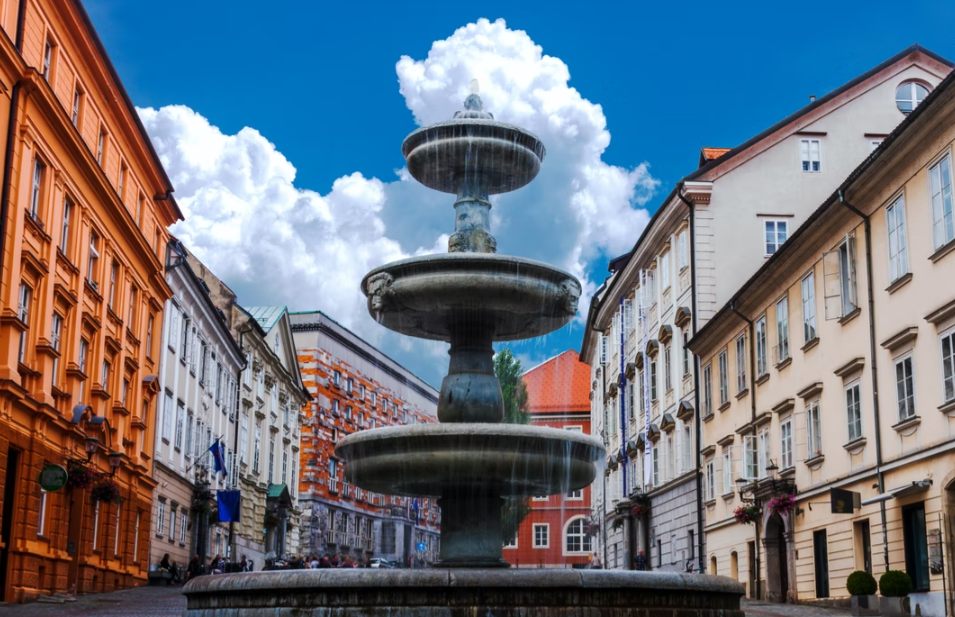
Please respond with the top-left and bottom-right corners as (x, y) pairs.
(86, 0), (955, 385)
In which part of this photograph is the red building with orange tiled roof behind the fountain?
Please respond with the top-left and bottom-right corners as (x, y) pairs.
(504, 350), (593, 568)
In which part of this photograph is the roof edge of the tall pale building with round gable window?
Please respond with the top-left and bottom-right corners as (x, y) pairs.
(608, 44), (955, 272)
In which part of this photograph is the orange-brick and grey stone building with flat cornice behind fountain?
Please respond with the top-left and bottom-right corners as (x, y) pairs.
(291, 311), (441, 565)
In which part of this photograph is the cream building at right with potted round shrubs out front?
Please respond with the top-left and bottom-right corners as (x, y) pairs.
(691, 63), (955, 616)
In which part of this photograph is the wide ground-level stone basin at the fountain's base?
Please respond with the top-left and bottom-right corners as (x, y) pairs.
(183, 568), (743, 617)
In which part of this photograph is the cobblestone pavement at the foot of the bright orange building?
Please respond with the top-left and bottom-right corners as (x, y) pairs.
(0, 586), (186, 617)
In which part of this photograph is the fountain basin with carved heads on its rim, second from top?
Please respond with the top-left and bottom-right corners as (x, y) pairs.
(361, 253), (580, 341)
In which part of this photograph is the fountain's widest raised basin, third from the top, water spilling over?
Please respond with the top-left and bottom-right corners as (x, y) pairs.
(335, 424), (606, 496)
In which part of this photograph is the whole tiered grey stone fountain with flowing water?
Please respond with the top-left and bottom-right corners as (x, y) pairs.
(183, 82), (742, 617)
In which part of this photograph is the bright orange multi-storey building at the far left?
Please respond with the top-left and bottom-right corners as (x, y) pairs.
(0, 0), (181, 602)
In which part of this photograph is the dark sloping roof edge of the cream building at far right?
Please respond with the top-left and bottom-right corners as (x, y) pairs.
(690, 56), (955, 353)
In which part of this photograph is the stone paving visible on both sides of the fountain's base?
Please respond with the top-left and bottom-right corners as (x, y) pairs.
(0, 586), (850, 617)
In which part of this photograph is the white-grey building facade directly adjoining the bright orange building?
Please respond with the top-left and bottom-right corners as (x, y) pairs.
(150, 239), (245, 567)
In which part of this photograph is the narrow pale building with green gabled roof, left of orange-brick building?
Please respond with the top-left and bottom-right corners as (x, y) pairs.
(186, 254), (309, 570)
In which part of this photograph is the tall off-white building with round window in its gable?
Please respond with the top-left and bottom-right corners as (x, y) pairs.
(581, 46), (952, 571)
